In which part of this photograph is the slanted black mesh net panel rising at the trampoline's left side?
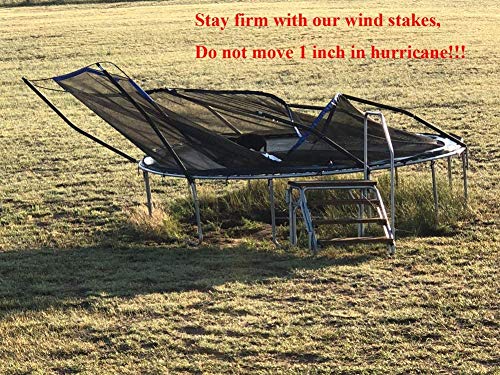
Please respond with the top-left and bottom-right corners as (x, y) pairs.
(58, 70), (282, 173)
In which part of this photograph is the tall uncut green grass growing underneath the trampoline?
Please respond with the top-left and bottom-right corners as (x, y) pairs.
(159, 171), (472, 244)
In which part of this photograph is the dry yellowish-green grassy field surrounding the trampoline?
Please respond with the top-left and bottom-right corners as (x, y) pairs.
(0, 0), (500, 374)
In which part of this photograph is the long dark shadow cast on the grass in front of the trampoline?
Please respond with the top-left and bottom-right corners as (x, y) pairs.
(0, 241), (371, 317)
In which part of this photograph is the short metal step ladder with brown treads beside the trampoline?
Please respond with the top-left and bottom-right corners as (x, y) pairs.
(286, 179), (396, 254)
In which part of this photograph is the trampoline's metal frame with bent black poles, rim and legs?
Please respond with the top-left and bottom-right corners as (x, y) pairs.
(22, 62), (468, 245)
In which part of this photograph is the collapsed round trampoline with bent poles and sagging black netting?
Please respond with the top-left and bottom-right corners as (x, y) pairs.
(23, 62), (467, 242)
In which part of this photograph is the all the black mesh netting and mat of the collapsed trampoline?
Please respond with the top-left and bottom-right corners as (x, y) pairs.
(50, 68), (439, 176)
